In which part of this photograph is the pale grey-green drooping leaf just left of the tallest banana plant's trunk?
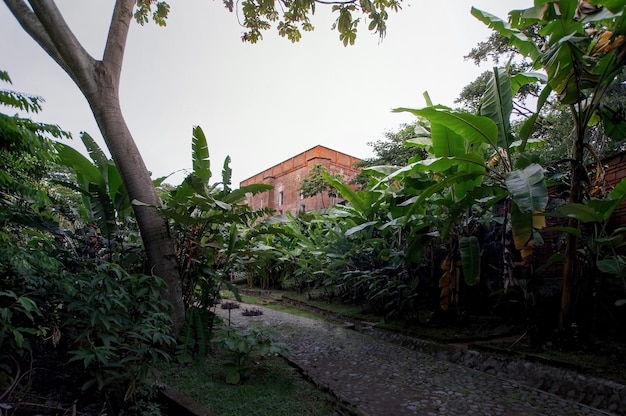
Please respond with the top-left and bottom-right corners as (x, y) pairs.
(506, 164), (548, 214)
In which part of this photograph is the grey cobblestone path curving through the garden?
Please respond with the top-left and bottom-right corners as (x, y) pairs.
(217, 302), (612, 416)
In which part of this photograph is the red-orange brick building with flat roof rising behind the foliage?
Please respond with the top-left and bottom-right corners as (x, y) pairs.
(240, 145), (361, 214)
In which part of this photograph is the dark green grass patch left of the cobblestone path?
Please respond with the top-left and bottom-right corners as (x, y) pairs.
(160, 353), (336, 416)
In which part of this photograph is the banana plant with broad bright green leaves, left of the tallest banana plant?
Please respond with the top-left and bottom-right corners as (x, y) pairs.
(385, 68), (548, 306)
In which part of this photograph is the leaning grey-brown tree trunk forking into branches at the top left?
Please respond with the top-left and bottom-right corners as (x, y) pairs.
(4, 0), (185, 337)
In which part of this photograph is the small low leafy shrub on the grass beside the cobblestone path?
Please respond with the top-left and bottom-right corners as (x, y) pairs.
(214, 325), (291, 384)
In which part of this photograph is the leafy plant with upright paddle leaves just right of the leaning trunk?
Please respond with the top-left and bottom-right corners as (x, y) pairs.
(162, 127), (271, 316)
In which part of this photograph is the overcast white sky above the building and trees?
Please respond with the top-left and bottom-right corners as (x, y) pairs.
(0, 0), (533, 187)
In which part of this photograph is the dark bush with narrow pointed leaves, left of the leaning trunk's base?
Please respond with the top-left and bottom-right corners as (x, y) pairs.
(63, 263), (174, 397)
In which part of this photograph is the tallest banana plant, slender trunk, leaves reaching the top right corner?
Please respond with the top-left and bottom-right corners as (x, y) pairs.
(472, 0), (626, 330)
